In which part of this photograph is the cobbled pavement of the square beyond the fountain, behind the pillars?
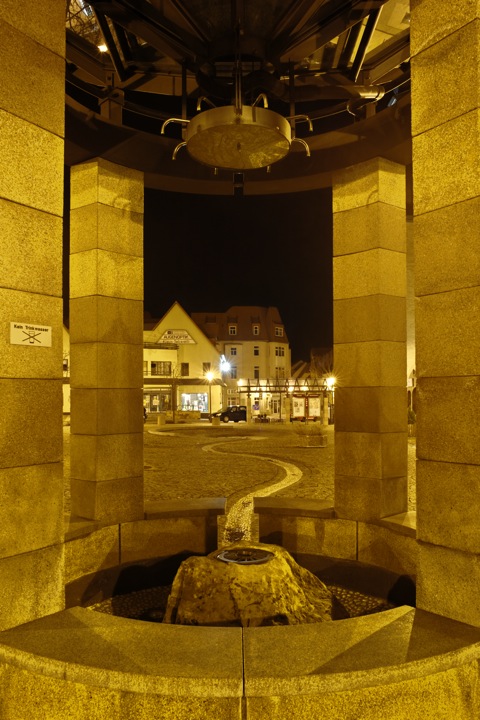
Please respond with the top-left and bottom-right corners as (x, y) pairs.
(64, 422), (416, 513)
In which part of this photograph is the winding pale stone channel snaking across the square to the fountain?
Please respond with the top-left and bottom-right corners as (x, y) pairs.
(202, 436), (303, 545)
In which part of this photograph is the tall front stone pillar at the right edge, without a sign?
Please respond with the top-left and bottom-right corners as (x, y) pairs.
(411, 0), (480, 626)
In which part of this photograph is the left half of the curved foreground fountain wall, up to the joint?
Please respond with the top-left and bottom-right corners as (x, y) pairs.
(0, 607), (243, 720)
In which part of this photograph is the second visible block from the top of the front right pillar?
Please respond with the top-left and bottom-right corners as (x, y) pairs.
(412, 19), (480, 135)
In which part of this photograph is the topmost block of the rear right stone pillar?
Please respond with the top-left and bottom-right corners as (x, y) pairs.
(333, 158), (406, 213)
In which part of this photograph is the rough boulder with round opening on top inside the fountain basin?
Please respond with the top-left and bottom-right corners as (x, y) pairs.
(163, 543), (348, 627)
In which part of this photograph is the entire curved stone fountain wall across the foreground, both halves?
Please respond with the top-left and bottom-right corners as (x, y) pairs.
(0, 606), (480, 720)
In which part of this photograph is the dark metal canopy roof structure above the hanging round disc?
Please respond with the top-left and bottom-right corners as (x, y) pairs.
(66, 0), (410, 194)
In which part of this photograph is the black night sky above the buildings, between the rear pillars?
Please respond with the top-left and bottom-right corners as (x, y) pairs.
(144, 188), (332, 362)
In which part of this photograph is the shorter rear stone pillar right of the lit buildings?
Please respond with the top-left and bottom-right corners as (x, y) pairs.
(333, 158), (407, 521)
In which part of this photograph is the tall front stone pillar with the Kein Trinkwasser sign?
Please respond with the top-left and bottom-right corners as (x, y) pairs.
(0, 0), (65, 630)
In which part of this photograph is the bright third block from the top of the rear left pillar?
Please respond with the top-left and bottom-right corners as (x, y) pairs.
(70, 250), (143, 300)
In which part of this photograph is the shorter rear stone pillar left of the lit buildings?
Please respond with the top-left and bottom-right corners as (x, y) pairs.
(70, 159), (143, 524)
